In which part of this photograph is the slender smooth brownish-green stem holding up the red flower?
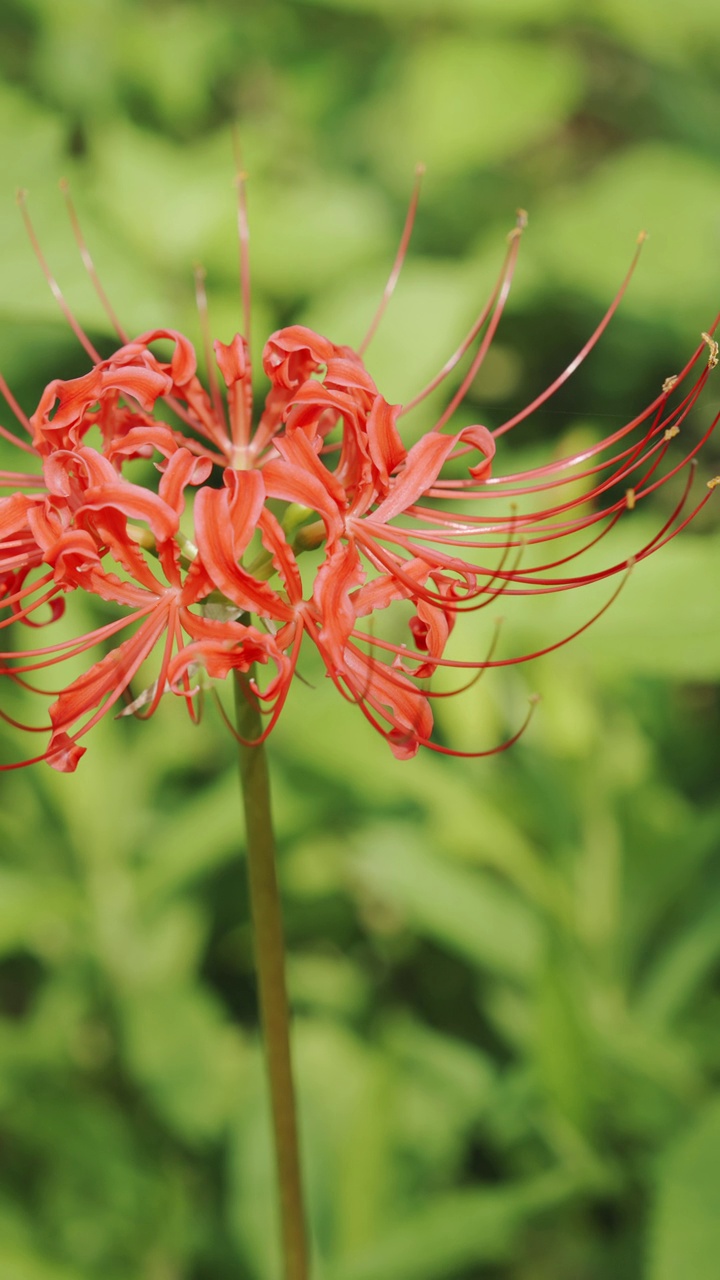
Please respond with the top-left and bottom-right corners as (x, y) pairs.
(234, 672), (309, 1280)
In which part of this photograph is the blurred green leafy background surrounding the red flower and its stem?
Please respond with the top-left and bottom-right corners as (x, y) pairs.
(0, 0), (720, 1280)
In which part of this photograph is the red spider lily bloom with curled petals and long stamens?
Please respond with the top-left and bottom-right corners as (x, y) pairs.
(0, 174), (720, 771)
